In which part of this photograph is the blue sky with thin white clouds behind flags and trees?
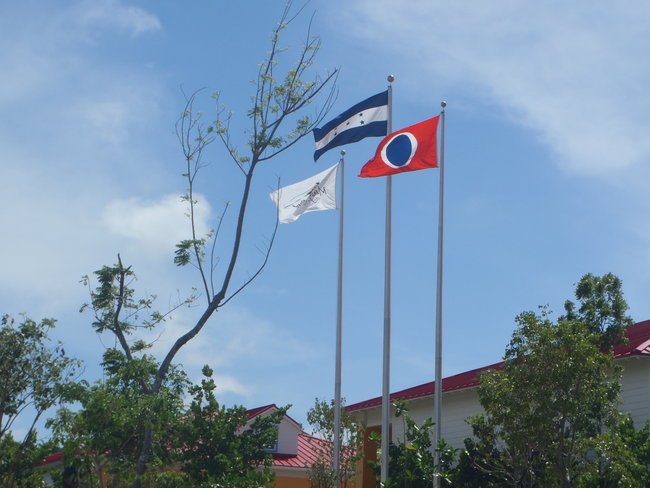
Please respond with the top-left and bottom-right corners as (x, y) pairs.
(0, 0), (650, 434)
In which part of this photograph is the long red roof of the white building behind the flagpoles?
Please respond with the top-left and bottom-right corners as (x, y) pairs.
(345, 320), (650, 411)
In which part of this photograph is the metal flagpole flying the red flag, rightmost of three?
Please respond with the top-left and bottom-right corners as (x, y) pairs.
(433, 101), (447, 488)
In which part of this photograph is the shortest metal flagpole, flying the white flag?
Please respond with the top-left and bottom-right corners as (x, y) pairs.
(333, 151), (345, 486)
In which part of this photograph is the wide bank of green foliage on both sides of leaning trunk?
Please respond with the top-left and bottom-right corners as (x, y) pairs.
(48, 362), (287, 488)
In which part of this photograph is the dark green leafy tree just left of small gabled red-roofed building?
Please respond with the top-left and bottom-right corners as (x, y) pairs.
(175, 366), (288, 488)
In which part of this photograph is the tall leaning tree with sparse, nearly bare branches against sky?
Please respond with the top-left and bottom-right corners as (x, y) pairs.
(131, 2), (338, 482)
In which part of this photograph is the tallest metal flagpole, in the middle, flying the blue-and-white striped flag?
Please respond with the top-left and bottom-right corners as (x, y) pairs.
(381, 75), (395, 483)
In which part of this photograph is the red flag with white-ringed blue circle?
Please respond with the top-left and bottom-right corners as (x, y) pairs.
(359, 115), (440, 178)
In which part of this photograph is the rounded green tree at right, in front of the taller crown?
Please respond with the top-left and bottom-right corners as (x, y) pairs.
(466, 310), (620, 486)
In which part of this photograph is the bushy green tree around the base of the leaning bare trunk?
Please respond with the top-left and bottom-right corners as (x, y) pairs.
(48, 348), (188, 486)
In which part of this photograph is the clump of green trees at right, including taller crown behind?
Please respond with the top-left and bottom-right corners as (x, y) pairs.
(460, 275), (634, 487)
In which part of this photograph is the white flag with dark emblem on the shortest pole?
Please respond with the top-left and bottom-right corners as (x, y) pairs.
(270, 163), (339, 224)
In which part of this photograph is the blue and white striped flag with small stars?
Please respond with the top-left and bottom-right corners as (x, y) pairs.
(314, 91), (388, 161)
